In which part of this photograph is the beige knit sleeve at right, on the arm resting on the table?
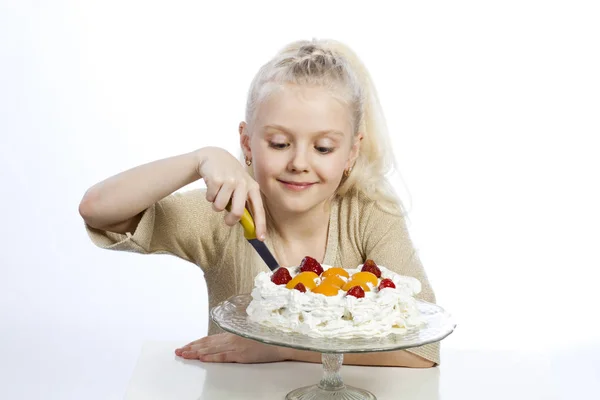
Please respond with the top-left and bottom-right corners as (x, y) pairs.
(361, 204), (440, 364)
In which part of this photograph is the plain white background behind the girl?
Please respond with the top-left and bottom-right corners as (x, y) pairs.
(0, 0), (600, 399)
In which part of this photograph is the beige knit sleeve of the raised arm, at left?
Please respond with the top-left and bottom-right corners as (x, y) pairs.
(85, 189), (229, 272)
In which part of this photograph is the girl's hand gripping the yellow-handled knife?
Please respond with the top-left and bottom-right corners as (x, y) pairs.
(197, 147), (267, 240)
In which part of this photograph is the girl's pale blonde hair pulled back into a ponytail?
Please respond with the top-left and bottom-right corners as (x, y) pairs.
(246, 39), (403, 213)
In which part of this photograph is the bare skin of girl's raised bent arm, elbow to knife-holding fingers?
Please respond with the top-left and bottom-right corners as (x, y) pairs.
(79, 147), (266, 239)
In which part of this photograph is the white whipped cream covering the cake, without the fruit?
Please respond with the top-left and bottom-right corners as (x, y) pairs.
(246, 264), (422, 339)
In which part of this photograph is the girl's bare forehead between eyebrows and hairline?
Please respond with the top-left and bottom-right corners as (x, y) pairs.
(255, 85), (352, 135)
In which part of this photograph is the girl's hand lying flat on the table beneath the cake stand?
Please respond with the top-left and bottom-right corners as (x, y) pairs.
(175, 332), (286, 364)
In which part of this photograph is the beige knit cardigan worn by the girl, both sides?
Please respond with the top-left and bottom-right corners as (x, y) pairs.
(86, 189), (440, 364)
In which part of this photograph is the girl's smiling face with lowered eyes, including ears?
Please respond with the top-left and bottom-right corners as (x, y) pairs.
(242, 85), (361, 213)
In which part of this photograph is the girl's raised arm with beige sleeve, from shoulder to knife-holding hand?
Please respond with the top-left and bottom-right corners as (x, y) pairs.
(79, 147), (266, 272)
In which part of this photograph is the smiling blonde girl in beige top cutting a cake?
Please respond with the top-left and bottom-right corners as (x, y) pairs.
(79, 40), (439, 367)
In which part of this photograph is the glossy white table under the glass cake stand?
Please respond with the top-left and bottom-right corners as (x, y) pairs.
(125, 342), (600, 400)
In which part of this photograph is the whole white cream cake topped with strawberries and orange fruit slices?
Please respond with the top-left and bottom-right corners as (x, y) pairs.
(246, 257), (422, 339)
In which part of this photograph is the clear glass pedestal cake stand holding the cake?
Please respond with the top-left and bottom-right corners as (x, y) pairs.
(210, 294), (456, 400)
